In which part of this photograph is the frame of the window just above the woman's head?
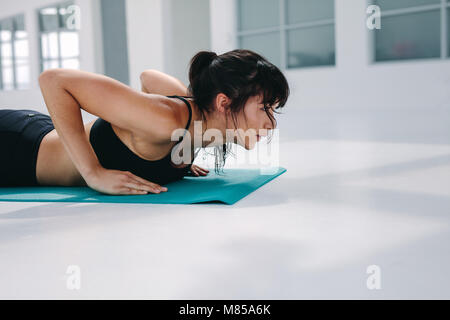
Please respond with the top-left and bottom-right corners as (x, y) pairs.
(234, 0), (337, 70)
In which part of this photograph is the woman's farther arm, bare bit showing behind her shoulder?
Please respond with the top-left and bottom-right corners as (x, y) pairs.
(140, 69), (188, 96)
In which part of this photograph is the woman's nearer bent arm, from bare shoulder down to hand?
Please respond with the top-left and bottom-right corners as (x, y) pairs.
(39, 69), (178, 193)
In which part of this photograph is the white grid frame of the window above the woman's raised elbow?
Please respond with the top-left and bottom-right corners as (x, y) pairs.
(36, 0), (81, 72)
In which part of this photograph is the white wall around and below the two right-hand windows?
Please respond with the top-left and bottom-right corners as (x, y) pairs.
(210, 0), (450, 108)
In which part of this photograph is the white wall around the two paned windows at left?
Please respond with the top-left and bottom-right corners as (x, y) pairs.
(0, 0), (103, 121)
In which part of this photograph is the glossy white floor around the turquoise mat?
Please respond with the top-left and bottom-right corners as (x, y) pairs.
(0, 108), (450, 299)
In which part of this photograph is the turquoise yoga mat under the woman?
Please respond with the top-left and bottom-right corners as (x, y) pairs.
(0, 167), (286, 205)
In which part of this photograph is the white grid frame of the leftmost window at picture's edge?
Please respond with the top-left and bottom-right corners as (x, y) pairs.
(0, 13), (31, 91)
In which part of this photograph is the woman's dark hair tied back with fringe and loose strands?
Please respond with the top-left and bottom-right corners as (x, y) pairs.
(188, 49), (290, 173)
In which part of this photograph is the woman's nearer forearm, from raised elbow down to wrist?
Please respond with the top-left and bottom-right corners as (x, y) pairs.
(39, 72), (100, 178)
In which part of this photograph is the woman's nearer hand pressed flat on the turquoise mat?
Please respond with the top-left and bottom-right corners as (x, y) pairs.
(85, 167), (167, 195)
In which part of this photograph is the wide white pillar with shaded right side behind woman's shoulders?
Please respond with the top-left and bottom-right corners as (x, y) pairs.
(126, 0), (211, 90)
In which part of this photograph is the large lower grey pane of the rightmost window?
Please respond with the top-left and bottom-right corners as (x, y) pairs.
(375, 10), (441, 61)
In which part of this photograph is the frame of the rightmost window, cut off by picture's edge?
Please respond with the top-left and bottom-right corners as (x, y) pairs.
(367, 0), (450, 64)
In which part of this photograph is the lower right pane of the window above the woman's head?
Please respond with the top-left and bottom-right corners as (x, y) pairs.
(287, 25), (335, 68)
